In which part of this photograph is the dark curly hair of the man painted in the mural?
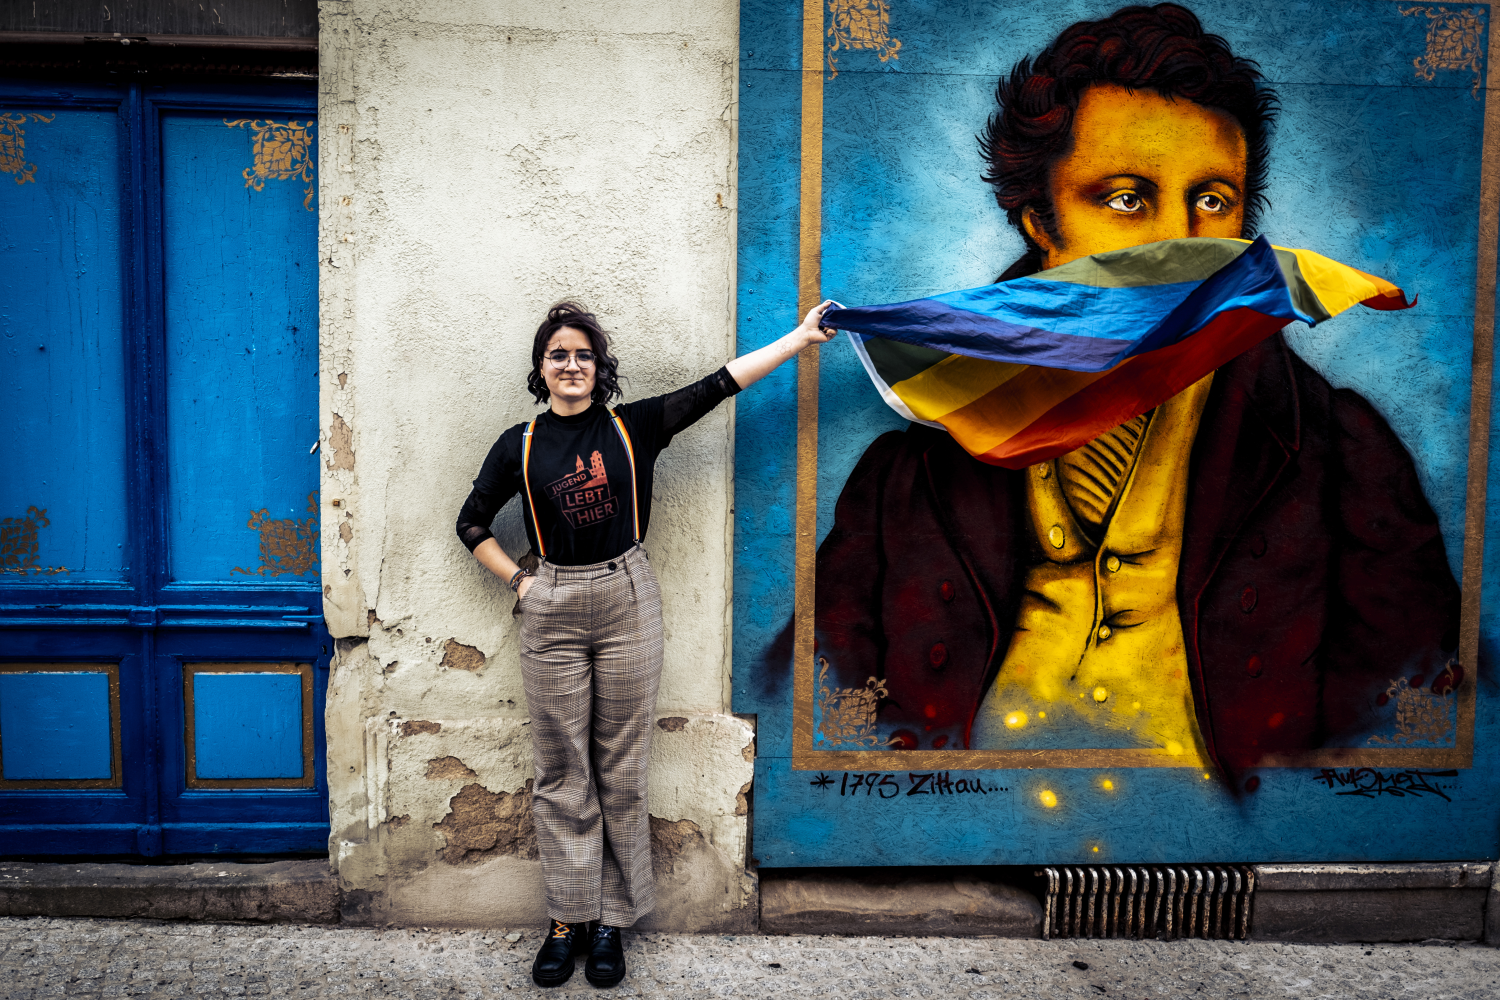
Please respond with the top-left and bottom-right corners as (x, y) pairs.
(978, 3), (1280, 279)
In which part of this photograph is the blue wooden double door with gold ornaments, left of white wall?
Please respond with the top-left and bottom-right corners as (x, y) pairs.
(0, 84), (329, 855)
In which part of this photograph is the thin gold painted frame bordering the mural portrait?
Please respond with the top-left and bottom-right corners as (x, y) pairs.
(792, 0), (1500, 771)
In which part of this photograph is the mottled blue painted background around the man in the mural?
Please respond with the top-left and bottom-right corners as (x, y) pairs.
(734, 0), (1500, 867)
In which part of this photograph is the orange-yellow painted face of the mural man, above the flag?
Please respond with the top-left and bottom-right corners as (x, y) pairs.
(1022, 84), (1247, 267)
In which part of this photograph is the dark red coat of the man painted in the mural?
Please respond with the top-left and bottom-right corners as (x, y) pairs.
(804, 334), (1458, 780)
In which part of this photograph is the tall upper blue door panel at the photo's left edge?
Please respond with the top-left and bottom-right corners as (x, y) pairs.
(0, 106), (129, 586)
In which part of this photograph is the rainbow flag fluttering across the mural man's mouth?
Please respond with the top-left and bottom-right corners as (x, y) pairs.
(824, 237), (1415, 469)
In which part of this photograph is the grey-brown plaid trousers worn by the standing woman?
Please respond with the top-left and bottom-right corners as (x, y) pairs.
(521, 546), (662, 927)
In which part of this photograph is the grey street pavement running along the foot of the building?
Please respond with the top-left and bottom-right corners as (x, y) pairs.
(0, 918), (1500, 1000)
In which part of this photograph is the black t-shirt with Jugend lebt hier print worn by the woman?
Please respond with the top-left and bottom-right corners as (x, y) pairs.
(458, 369), (740, 565)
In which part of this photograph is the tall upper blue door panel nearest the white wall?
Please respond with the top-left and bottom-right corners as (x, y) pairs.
(161, 112), (318, 583)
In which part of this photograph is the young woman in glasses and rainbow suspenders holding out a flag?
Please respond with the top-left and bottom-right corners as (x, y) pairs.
(458, 301), (836, 987)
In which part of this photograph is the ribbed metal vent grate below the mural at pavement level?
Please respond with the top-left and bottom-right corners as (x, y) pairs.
(1037, 865), (1256, 940)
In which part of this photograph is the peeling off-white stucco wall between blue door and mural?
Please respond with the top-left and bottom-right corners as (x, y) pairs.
(320, 0), (753, 928)
